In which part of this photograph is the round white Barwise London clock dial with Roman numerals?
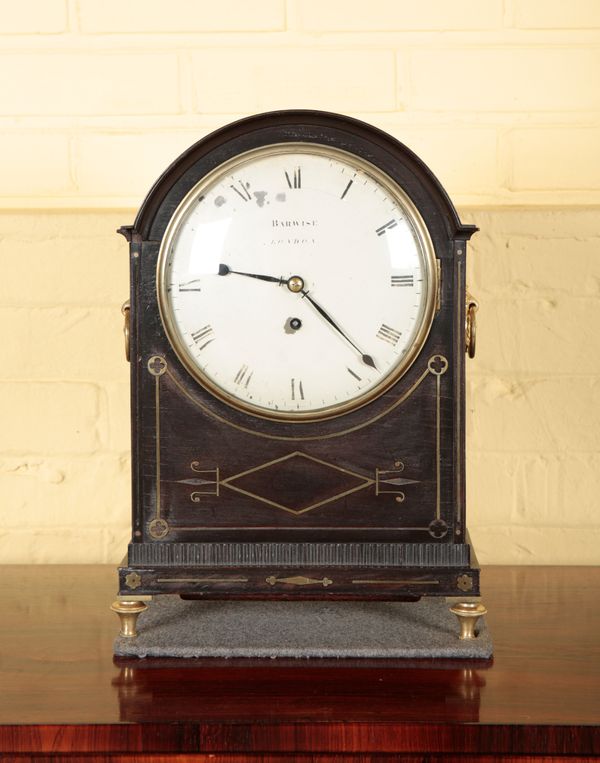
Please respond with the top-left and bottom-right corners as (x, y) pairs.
(157, 143), (436, 421)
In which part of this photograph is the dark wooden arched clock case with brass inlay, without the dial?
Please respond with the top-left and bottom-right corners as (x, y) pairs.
(119, 111), (479, 600)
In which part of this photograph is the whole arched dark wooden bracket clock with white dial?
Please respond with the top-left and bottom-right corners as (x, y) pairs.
(110, 111), (479, 632)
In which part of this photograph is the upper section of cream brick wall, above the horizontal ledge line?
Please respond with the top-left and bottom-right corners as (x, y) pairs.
(0, 0), (600, 209)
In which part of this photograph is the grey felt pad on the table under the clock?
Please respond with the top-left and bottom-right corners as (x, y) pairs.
(115, 596), (492, 659)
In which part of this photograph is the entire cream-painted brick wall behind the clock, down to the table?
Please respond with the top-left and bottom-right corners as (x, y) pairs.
(0, 0), (600, 564)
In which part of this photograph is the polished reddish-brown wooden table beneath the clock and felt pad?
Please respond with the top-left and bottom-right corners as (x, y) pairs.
(0, 565), (600, 763)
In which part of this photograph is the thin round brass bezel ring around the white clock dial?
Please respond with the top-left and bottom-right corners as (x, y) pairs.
(156, 141), (438, 423)
